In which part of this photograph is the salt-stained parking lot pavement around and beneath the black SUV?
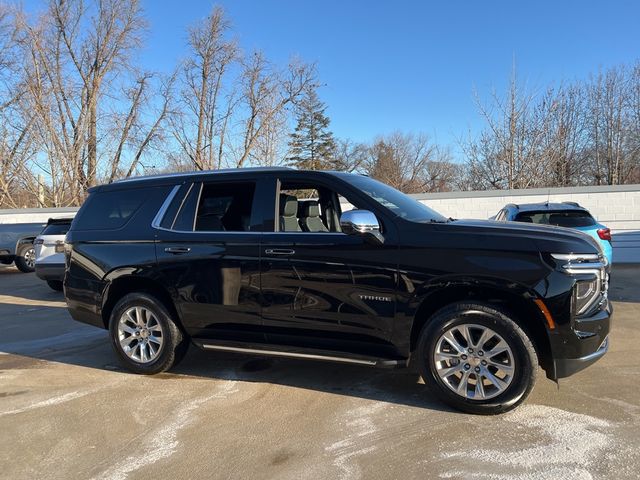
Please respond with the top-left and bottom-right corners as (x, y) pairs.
(0, 266), (640, 480)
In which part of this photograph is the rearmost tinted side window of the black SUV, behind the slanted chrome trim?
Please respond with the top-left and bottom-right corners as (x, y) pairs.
(74, 187), (150, 230)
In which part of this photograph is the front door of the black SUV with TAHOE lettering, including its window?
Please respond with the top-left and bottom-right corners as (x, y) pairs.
(260, 176), (397, 355)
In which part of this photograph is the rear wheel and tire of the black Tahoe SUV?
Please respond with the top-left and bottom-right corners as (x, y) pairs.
(109, 292), (189, 375)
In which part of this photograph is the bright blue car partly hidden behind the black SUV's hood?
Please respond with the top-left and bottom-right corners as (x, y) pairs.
(494, 202), (613, 263)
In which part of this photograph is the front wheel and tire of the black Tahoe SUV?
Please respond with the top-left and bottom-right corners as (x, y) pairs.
(415, 302), (538, 415)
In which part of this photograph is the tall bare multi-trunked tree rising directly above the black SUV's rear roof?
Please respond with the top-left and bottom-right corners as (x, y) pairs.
(21, 0), (145, 204)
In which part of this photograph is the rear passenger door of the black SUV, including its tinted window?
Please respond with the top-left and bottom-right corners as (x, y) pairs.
(154, 175), (264, 341)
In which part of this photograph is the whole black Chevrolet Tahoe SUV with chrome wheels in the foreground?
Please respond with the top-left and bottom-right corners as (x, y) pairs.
(64, 168), (611, 413)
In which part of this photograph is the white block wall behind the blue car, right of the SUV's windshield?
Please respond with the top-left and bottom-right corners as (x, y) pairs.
(413, 185), (640, 263)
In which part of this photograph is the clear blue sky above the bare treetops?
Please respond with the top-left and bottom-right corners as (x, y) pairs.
(22, 0), (640, 161)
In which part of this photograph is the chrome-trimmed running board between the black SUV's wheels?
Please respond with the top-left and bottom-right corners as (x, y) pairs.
(193, 338), (407, 368)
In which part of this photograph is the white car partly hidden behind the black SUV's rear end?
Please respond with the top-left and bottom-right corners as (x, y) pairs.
(33, 217), (73, 292)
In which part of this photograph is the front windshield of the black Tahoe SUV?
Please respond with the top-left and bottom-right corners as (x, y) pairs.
(343, 174), (447, 222)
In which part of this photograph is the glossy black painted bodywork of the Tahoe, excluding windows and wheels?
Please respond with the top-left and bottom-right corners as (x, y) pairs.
(65, 169), (610, 378)
